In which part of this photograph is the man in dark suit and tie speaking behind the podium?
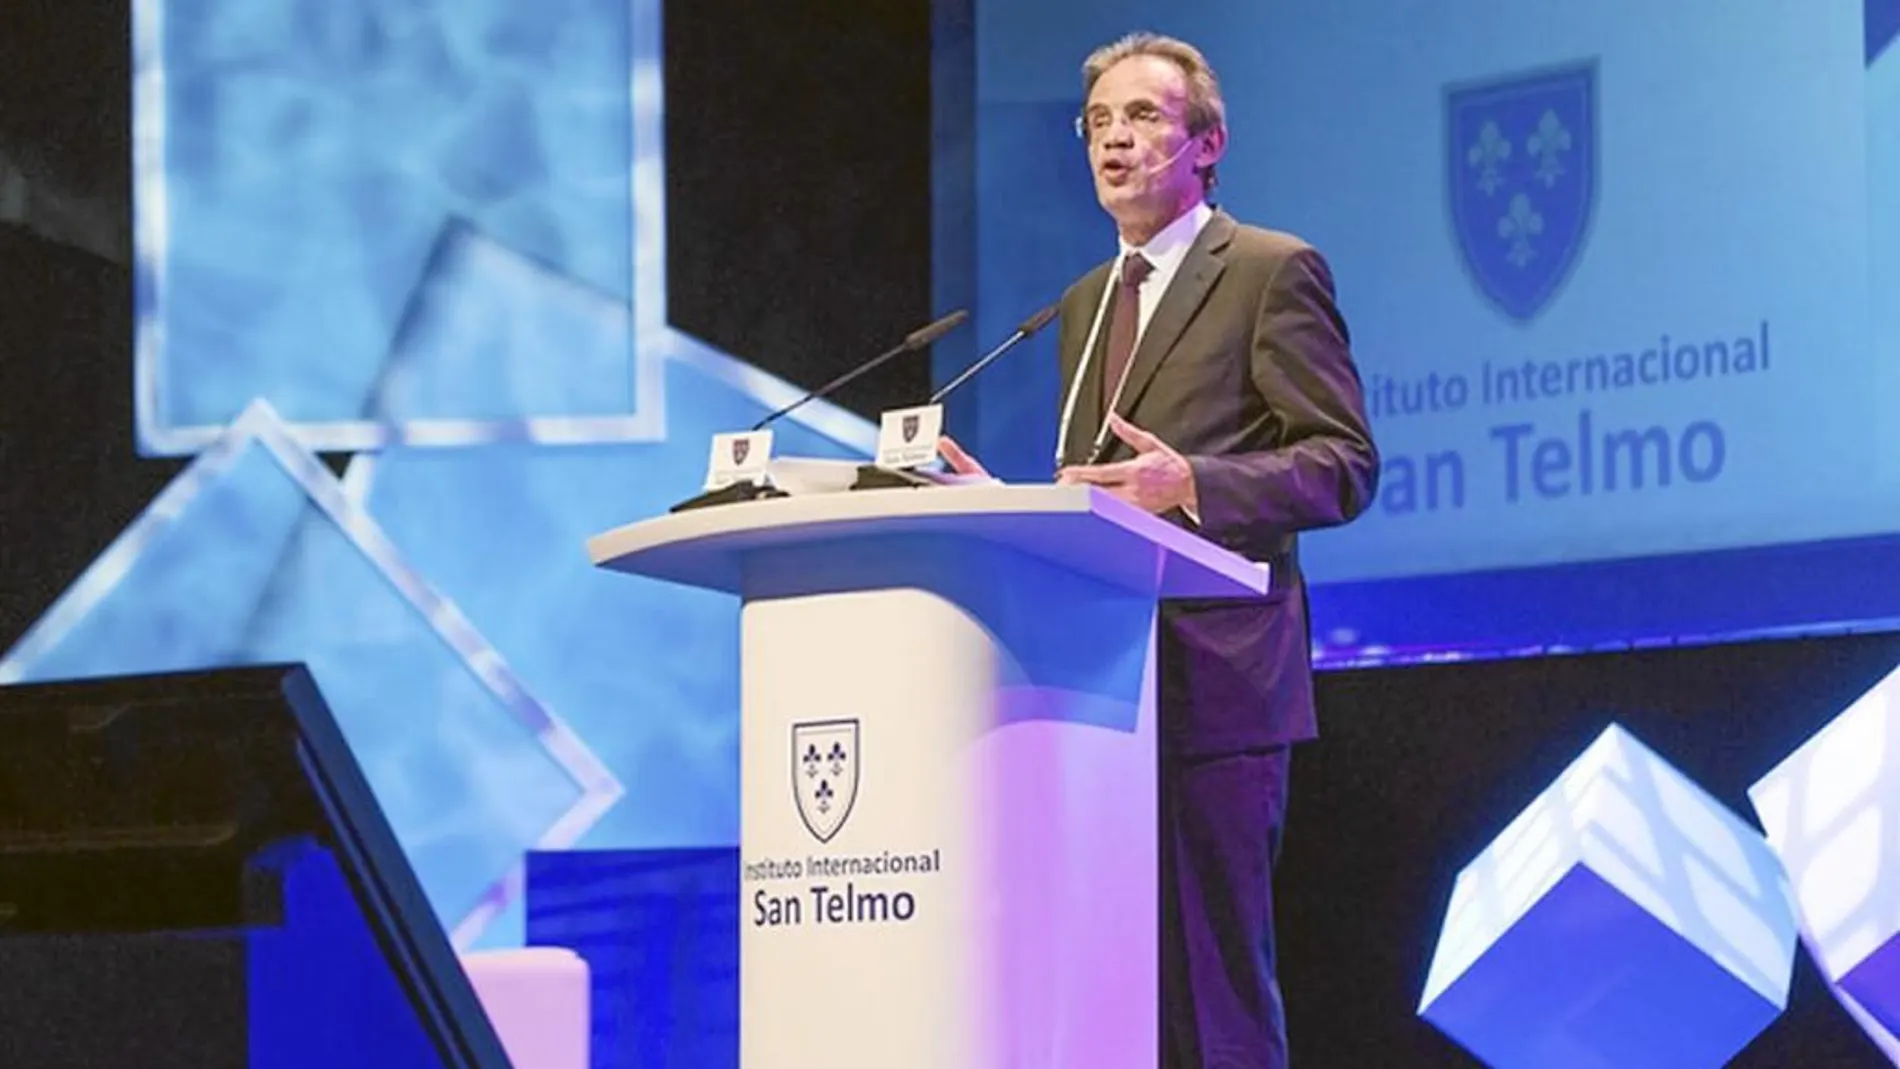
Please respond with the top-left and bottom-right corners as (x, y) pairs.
(942, 34), (1378, 1069)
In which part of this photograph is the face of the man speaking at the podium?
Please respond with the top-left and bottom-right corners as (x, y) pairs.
(1083, 55), (1212, 235)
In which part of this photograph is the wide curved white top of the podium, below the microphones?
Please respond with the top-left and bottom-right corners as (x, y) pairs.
(587, 484), (1269, 598)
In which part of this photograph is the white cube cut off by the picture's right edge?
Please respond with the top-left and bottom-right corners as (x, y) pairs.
(1748, 668), (1900, 1056)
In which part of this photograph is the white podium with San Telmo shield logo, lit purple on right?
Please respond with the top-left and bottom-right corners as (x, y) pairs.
(587, 484), (1269, 1069)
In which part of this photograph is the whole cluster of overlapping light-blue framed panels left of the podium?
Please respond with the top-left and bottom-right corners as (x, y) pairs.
(0, 0), (874, 947)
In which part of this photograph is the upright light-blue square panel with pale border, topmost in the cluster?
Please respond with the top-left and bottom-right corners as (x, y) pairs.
(133, 0), (661, 454)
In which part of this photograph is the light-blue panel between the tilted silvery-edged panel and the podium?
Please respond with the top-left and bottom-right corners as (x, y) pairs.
(346, 337), (863, 938)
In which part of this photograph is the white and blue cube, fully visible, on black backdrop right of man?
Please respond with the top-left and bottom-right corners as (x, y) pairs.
(1419, 725), (1797, 1069)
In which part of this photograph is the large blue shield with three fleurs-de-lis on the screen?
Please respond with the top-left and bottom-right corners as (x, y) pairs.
(1446, 59), (1596, 321)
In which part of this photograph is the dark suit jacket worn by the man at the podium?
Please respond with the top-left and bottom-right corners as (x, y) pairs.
(1058, 211), (1379, 756)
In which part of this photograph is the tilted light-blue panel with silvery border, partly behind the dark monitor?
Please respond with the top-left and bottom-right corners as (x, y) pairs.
(0, 403), (621, 938)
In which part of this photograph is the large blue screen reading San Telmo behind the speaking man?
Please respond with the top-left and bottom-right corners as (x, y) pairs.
(939, 0), (1900, 651)
